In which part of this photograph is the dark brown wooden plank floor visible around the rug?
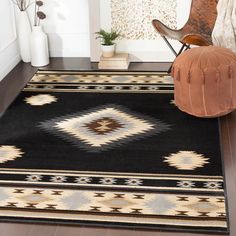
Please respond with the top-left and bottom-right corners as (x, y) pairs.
(0, 58), (236, 236)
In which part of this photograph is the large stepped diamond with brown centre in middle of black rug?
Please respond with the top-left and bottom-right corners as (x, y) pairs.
(40, 105), (169, 152)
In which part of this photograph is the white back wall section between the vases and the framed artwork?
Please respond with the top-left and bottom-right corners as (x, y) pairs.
(26, 0), (90, 57)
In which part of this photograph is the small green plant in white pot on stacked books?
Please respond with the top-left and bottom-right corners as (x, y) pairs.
(96, 29), (120, 57)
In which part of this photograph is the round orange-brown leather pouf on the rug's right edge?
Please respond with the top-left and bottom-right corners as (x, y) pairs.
(172, 46), (236, 117)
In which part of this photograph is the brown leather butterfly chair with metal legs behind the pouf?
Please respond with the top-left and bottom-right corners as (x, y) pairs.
(152, 0), (218, 71)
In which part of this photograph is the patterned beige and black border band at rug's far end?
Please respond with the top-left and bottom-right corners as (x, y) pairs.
(24, 71), (174, 93)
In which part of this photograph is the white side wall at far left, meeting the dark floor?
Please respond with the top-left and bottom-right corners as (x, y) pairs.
(0, 0), (20, 80)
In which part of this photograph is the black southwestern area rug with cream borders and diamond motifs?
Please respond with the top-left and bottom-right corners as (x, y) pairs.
(0, 72), (228, 233)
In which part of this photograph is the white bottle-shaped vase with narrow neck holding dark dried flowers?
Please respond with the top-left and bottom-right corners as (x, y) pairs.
(30, 26), (49, 67)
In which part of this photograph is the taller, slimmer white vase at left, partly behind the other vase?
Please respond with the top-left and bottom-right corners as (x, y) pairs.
(17, 11), (31, 62)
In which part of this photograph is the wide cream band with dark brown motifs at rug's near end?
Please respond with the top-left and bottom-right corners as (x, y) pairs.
(0, 187), (225, 218)
